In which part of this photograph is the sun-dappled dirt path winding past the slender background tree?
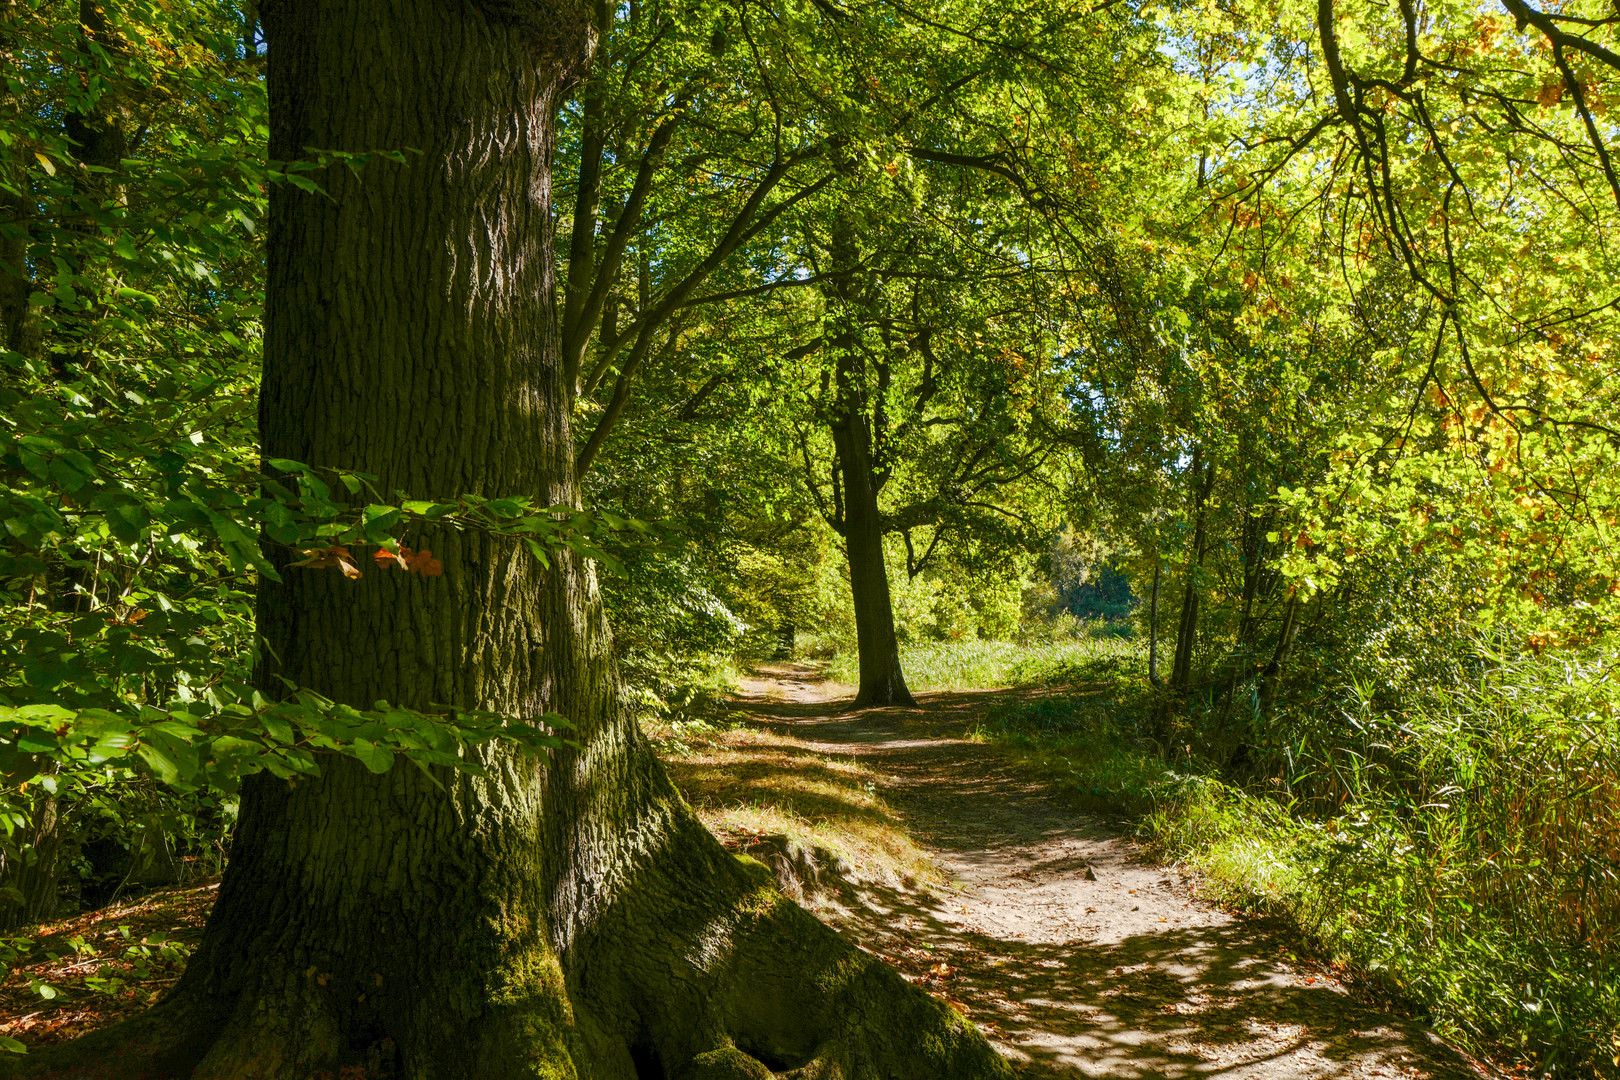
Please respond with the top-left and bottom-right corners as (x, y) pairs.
(737, 665), (1479, 1080)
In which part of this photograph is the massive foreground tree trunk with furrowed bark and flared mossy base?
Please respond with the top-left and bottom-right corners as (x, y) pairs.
(11, 0), (1009, 1080)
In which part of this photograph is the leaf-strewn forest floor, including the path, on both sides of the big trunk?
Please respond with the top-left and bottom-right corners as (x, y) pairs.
(0, 664), (1509, 1080)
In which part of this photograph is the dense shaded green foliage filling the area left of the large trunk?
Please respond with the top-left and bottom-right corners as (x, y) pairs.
(0, 0), (268, 923)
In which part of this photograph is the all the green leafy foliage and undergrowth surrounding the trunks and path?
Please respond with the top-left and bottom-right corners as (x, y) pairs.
(0, 0), (1620, 1075)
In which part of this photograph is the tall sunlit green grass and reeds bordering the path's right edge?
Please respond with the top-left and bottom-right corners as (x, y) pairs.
(982, 657), (1620, 1080)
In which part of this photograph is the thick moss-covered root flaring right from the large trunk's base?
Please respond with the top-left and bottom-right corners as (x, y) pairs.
(570, 842), (1013, 1080)
